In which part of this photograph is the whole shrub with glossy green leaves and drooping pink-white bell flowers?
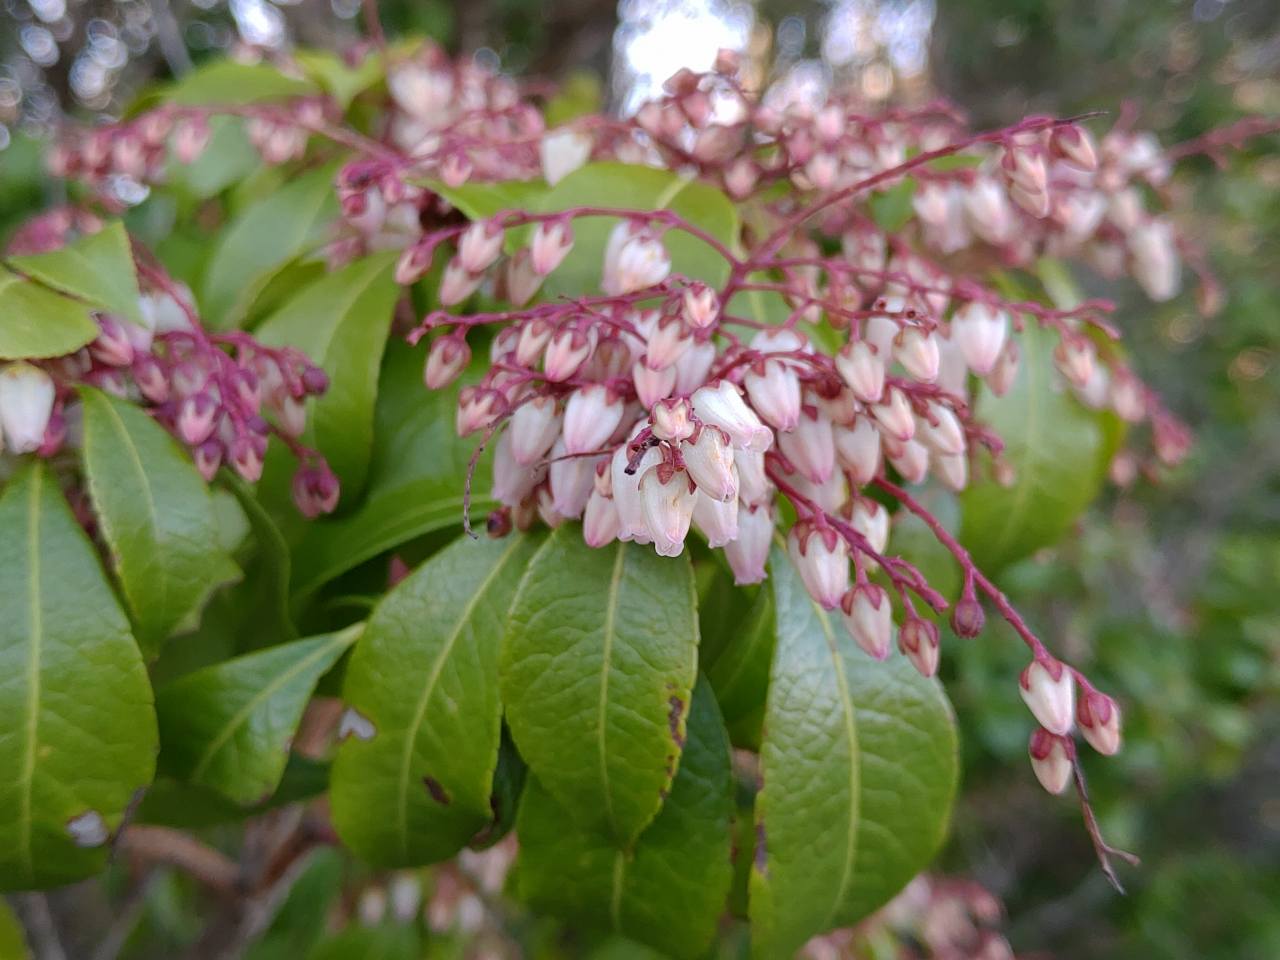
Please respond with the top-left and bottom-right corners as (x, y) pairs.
(0, 35), (1266, 956)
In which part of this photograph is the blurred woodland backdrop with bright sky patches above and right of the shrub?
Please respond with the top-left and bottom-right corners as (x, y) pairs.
(0, 0), (1280, 960)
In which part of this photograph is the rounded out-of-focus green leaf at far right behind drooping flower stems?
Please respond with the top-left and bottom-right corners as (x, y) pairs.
(960, 320), (1105, 572)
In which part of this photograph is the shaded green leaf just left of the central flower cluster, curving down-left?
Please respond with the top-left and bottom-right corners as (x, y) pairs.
(293, 338), (489, 605)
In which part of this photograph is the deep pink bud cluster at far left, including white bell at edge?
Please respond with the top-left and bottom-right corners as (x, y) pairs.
(0, 227), (339, 517)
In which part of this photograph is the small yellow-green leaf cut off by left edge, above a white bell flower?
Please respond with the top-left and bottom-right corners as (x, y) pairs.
(0, 266), (97, 360)
